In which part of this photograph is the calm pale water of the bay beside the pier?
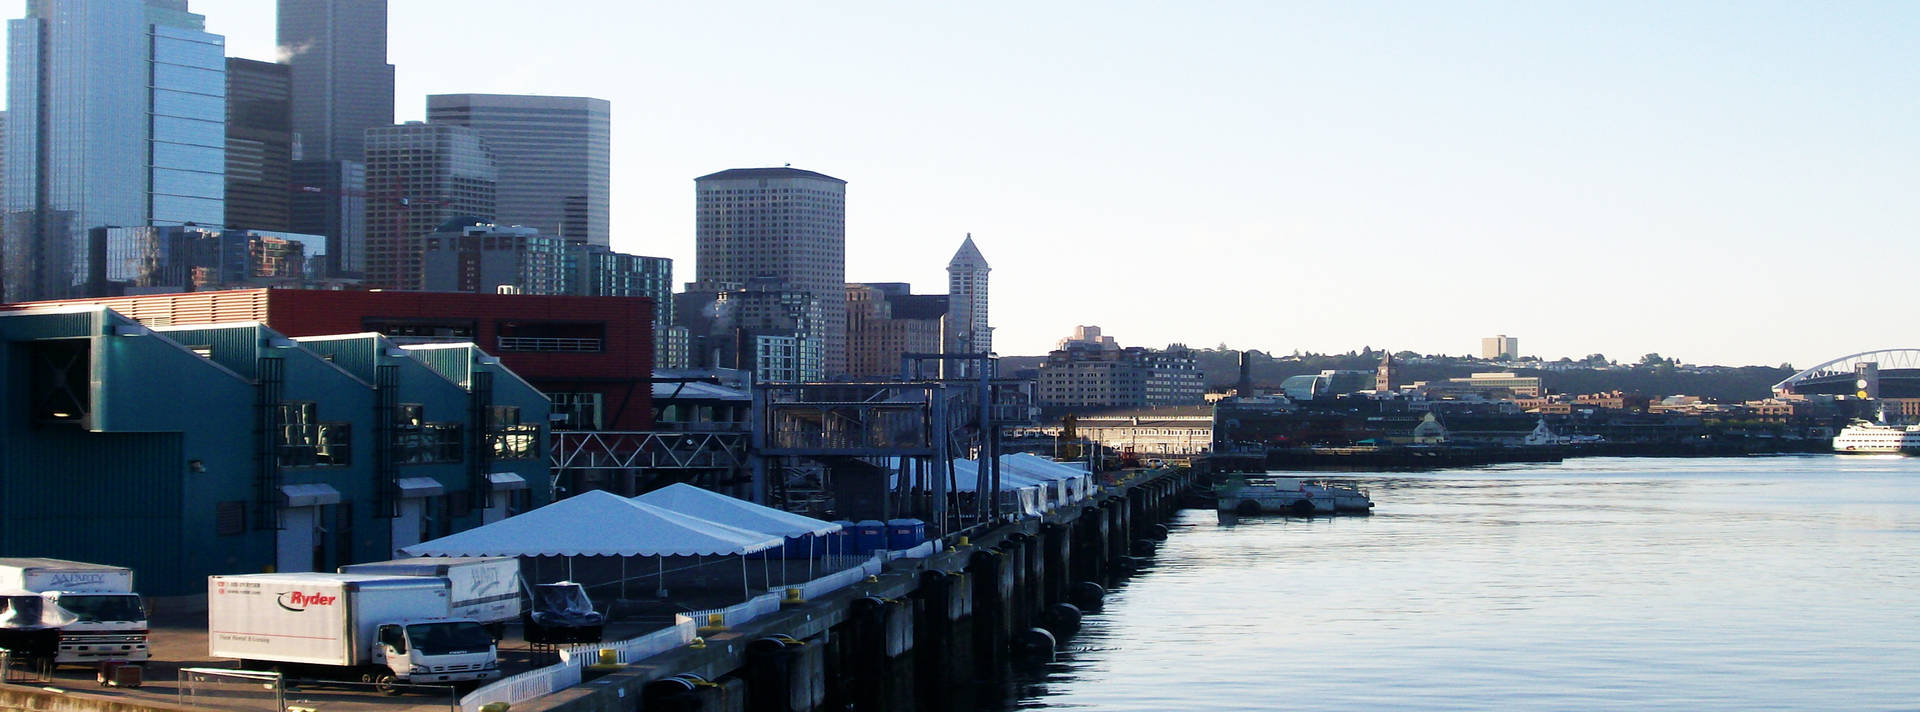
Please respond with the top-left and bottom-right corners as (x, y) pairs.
(1020, 457), (1920, 710)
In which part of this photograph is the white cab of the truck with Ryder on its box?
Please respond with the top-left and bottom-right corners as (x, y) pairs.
(371, 618), (499, 695)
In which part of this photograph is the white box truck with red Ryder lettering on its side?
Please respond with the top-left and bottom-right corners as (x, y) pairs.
(207, 574), (499, 695)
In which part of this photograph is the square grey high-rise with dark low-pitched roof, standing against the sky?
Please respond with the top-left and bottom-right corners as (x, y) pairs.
(693, 167), (847, 376)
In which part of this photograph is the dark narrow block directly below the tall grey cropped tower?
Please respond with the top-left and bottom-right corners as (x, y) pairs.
(288, 161), (367, 278)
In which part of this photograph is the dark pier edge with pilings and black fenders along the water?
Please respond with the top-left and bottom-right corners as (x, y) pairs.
(513, 470), (1194, 712)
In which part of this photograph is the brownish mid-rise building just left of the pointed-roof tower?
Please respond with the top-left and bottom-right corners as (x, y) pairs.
(847, 282), (948, 378)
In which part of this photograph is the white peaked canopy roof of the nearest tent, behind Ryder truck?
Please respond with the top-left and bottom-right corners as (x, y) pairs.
(401, 489), (783, 557)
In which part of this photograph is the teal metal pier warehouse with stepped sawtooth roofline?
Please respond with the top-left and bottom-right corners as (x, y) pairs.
(0, 305), (551, 595)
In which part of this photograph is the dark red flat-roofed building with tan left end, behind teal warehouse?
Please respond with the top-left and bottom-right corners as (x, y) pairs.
(16, 290), (653, 430)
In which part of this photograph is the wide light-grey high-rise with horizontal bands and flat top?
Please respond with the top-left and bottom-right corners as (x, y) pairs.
(426, 94), (612, 246)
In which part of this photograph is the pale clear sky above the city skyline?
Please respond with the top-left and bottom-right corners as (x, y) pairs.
(0, 0), (1920, 367)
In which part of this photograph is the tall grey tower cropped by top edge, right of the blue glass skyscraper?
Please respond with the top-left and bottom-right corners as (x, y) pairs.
(278, 0), (394, 161)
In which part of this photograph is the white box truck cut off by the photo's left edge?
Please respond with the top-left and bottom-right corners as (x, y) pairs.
(0, 558), (148, 664)
